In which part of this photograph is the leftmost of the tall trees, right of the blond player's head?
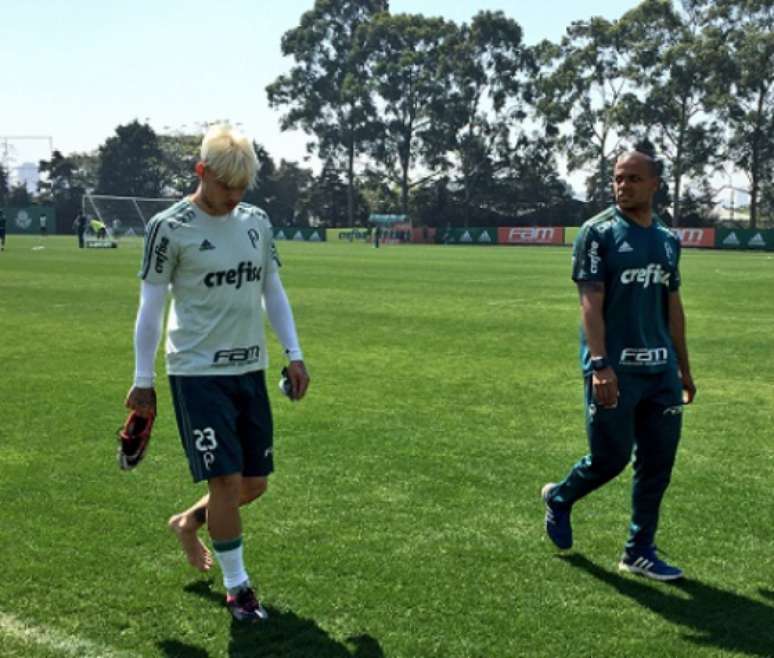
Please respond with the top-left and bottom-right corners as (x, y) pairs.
(266, 0), (388, 225)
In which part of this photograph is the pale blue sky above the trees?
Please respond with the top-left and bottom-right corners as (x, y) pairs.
(0, 0), (638, 174)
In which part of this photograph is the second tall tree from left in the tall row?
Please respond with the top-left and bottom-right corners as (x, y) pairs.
(359, 13), (457, 214)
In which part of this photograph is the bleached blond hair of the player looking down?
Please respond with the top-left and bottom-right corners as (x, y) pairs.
(201, 123), (258, 189)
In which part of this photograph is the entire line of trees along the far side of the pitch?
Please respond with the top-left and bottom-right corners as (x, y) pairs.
(0, 0), (774, 227)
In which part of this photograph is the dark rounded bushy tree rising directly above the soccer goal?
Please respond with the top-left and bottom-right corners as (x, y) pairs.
(96, 120), (167, 197)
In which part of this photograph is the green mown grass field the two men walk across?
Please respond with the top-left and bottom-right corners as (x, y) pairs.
(0, 236), (774, 658)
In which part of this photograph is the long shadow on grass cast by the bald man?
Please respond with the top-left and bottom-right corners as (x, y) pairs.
(561, 553), (774, 656)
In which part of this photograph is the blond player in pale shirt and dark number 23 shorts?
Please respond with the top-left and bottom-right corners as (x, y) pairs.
(126, 125), (309, 621)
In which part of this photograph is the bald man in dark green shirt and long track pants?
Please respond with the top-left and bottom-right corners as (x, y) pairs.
(542, 151), (696, 580)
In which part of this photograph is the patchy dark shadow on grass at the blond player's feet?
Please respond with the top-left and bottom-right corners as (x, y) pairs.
(158, 581), (384, 658)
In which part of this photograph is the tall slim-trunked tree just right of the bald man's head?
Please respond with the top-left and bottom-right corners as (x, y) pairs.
(620, 0), (721, 226)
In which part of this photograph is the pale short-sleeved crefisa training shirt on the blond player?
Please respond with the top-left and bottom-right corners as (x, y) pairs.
(140, 199), (280, 375)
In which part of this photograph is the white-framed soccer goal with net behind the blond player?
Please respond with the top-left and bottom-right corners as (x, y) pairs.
(82, 194), (179, 238)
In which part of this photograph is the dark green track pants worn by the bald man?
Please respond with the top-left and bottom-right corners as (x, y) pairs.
(551, 370), (683, 549)
